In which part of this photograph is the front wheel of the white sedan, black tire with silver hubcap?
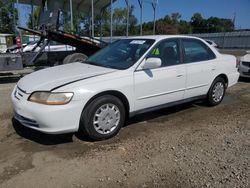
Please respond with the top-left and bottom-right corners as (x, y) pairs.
(79, 95), (125, 141)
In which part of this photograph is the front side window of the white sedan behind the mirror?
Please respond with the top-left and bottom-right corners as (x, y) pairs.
(148, 40), (181, 67)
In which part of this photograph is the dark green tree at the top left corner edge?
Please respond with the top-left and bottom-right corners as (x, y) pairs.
(0, 0), (18, 34)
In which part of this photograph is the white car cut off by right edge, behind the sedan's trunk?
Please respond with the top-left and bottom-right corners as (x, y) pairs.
(239, 51), (250, 78)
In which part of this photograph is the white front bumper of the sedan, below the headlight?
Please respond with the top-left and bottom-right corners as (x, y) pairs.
(11, 87), (83, 134)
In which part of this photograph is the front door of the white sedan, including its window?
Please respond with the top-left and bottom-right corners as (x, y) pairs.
(134, 39), (186, 111)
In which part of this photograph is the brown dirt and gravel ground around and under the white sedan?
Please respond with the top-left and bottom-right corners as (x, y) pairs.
(0, 76), (250, 188)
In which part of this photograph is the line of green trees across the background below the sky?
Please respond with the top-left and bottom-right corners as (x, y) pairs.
(0, 0), (235, 36)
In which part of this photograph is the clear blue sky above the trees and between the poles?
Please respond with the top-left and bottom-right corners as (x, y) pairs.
(20, 0), (250, 29)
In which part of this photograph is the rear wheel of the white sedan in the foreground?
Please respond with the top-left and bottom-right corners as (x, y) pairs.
(207, 77), (226, 106)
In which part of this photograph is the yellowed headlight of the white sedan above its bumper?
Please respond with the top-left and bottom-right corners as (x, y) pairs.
(28, 91), (74, 105)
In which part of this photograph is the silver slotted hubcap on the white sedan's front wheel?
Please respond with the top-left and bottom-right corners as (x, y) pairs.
(93, 104), (120, 134)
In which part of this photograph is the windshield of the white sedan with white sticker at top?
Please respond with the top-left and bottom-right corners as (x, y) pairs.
(84, 39), (155, 70)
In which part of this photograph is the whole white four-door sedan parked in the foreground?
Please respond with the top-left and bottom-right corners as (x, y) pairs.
(11, 36), (239, 140)
